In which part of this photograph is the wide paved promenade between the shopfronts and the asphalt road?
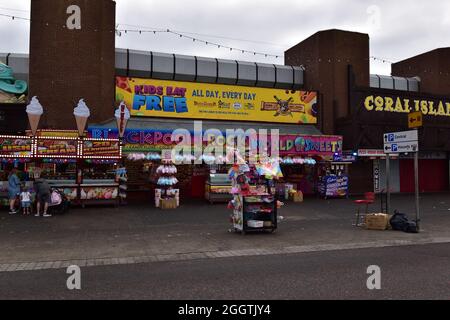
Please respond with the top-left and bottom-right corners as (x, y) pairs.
(0, 193), (450, 273)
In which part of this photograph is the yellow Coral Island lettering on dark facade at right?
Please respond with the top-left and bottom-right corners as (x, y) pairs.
(364, 95), (450, 117)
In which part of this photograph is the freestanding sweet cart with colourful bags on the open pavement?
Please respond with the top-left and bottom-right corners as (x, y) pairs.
(228, 152), (283, 234)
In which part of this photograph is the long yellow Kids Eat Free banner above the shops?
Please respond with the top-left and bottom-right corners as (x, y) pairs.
(116, 77), (318, 124)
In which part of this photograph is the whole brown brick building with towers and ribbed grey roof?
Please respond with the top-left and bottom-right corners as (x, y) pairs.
(0, 0), (450, 193)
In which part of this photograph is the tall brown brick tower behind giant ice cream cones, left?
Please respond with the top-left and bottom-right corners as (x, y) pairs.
(30, 0), (116, 129)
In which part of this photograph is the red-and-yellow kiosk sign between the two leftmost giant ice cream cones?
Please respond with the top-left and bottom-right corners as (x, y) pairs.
(36, 139), (77, 158)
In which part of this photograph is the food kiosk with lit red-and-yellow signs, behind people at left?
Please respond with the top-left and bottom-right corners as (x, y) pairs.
(0, 130), (123, 207)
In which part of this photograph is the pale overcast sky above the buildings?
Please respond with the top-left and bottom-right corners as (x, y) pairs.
(0, 0), (450, 74)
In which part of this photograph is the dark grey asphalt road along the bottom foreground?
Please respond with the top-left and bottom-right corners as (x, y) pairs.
(0, 244), (450, 300)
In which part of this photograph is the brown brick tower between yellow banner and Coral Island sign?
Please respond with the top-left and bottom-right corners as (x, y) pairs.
(285, 30), (370, 134)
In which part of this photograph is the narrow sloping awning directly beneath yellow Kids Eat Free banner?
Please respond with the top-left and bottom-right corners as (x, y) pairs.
(89, 118), (322, 136)
